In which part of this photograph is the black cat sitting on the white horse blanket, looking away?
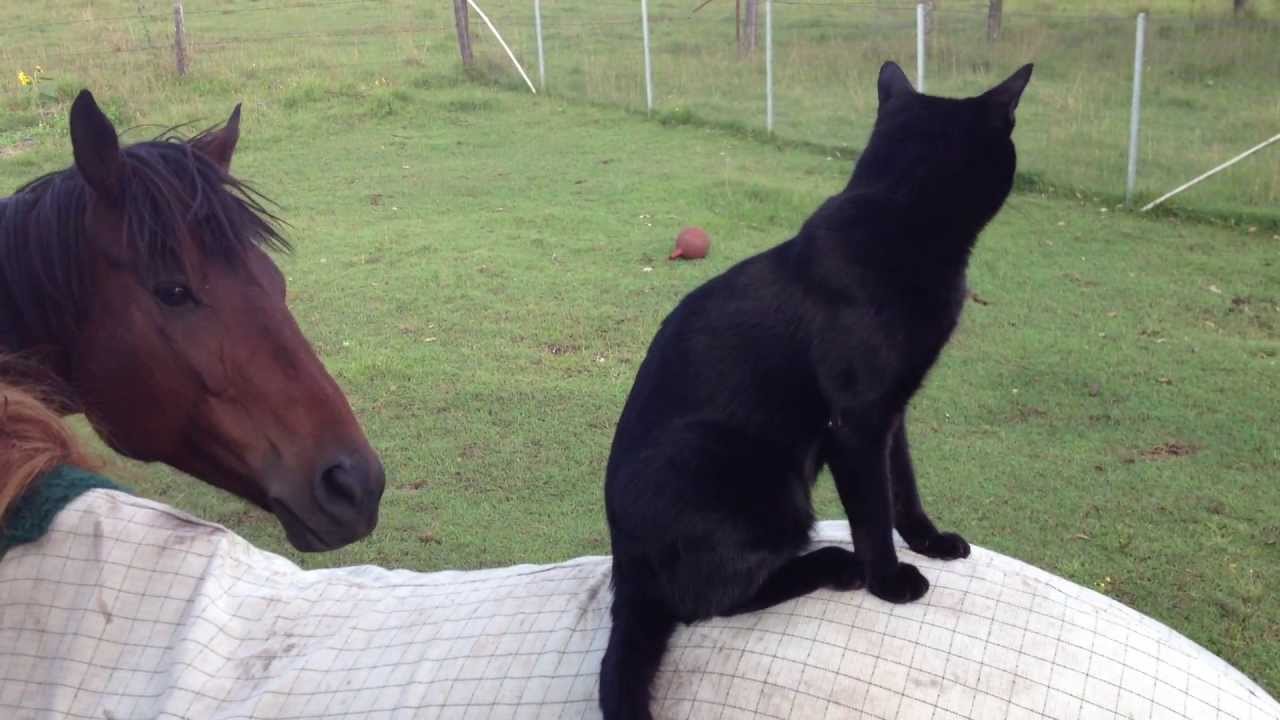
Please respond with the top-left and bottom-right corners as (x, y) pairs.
(600, 63), (1032, 720)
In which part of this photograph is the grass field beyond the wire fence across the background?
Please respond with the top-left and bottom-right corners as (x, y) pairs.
(0, 0), (1280, 218)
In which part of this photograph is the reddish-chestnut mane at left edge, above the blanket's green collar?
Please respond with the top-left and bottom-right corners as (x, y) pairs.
(0, 359), (99, 520)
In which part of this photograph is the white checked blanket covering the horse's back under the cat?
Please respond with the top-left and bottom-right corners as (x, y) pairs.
(0, 489), (1280, 720)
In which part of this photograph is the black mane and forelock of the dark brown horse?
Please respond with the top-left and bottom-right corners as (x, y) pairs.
(0, 129), (289, 350)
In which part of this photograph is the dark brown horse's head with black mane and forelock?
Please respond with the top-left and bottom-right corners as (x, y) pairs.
(0, 91), (384, 551)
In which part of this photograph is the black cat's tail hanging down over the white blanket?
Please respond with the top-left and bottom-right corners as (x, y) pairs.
(600, 573), (676, 720)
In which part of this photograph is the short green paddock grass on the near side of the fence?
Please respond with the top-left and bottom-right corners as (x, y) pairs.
(0, 3), (1280, 694)
